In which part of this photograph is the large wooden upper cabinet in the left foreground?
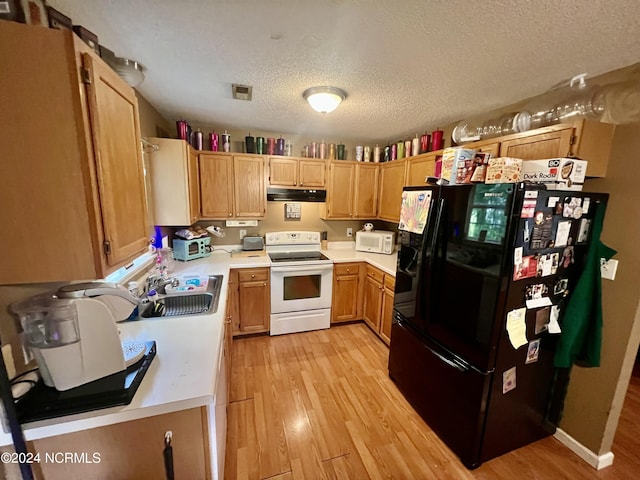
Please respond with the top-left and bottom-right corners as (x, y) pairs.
(0, 21), (151, 284)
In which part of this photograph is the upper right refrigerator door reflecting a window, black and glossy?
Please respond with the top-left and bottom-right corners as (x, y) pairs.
(419, 184), (514, 371)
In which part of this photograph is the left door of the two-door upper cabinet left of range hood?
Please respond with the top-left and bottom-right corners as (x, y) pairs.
(198, 153), (233, 219)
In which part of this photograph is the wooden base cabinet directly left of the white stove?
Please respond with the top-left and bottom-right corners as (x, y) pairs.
(229, 268), (271, 336)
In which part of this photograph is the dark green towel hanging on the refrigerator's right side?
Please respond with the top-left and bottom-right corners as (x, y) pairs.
(554, 203), (617, 368)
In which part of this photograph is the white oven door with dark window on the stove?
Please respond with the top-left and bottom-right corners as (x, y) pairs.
(271, 263), (333, 313)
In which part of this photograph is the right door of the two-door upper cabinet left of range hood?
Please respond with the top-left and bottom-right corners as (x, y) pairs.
(233, 155), (267, 218)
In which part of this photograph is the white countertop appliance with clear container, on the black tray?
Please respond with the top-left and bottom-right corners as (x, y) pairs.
(11, 282), (144, 391)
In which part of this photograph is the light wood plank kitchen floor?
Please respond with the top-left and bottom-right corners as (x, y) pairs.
(225, 323), (640, 480)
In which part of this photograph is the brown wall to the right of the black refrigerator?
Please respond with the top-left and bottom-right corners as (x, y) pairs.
(560, 124), (640, 454)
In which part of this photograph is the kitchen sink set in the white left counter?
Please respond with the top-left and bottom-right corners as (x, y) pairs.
(140, 275), (222, 318)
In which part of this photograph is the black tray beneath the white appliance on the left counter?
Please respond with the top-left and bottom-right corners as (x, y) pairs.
(16, 341), (156, 423)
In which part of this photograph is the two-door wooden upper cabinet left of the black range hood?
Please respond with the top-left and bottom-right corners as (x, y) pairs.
(198, 152), (267, 220)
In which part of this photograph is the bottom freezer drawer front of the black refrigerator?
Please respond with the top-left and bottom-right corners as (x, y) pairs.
(389, 321), (491, 468)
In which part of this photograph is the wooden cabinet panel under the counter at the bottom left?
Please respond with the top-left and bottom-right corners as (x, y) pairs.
(28, 407), (211, 480)
